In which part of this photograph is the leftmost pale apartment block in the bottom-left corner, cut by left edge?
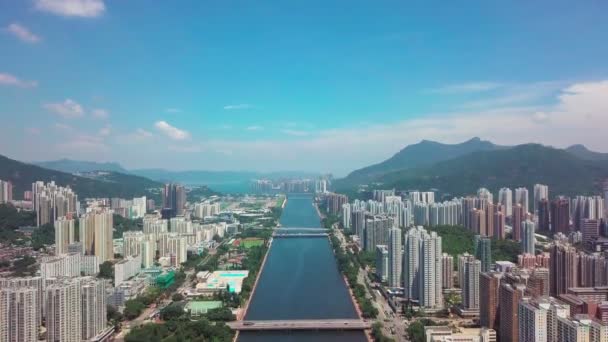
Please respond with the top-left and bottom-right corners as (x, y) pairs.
(0, 287), (40, 342)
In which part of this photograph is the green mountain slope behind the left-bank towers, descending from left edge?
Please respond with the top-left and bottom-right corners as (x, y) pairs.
(0, 156), (162, 199)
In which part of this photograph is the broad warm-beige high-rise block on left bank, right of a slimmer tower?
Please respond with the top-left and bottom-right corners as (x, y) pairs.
(78, 210), (114, 264)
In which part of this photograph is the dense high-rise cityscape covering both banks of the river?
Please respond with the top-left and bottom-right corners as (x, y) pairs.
(0, 170), (608, 342)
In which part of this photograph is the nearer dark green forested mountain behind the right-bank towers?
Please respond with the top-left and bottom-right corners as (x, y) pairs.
(364, 144), (608, 196)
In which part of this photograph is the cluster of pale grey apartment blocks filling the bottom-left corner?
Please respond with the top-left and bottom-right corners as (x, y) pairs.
(0, 269), (108, 342)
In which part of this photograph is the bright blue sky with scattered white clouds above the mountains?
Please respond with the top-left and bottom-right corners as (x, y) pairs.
(0, 0), (608, 175)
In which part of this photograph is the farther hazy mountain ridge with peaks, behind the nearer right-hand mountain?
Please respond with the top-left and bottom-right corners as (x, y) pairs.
(342, 138), (502, 184)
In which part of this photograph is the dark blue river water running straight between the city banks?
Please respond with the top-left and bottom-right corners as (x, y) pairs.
(239, 194), (366, 342)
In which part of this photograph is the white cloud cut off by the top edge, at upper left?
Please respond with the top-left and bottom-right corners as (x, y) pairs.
(35, 0), (106, 18)
